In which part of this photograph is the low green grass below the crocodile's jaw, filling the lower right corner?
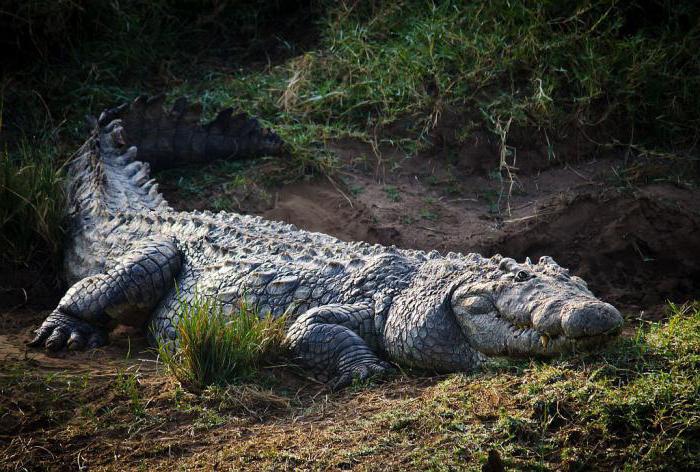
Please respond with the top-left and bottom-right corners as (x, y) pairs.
(374, 304), (700, 470)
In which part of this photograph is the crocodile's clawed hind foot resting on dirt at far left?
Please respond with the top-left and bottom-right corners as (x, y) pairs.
(27, 312), (107, 351)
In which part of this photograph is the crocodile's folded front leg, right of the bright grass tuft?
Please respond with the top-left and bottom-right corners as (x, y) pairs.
(286, 304), (393, 390)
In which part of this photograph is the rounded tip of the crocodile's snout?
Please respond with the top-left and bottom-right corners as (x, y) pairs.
(561, 300), (623, 338)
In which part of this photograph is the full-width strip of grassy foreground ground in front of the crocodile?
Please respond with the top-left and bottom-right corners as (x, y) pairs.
(0, 304), (700, 470)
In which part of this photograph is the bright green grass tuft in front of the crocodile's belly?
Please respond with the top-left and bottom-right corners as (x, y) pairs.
(157, 294), (284, 392)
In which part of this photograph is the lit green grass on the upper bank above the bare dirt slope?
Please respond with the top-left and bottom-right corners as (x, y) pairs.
(157, 0), (700, 172)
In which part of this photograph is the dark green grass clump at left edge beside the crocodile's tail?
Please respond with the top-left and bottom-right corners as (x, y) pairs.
(0, 141), (65, 264)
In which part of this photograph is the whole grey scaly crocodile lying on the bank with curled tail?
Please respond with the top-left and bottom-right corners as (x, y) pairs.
(29, 97), (623, 388)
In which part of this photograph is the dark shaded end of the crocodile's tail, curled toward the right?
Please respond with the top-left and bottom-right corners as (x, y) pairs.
(98, 95), (287, 170)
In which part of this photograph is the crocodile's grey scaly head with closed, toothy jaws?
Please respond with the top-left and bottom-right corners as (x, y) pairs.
(450, 255), (623, 356)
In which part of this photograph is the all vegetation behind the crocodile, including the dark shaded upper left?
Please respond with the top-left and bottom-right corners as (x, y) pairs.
(0, 0), (700, 266)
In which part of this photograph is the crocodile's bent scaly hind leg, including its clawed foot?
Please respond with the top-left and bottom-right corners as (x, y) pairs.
(29, 239), (181, 351)
